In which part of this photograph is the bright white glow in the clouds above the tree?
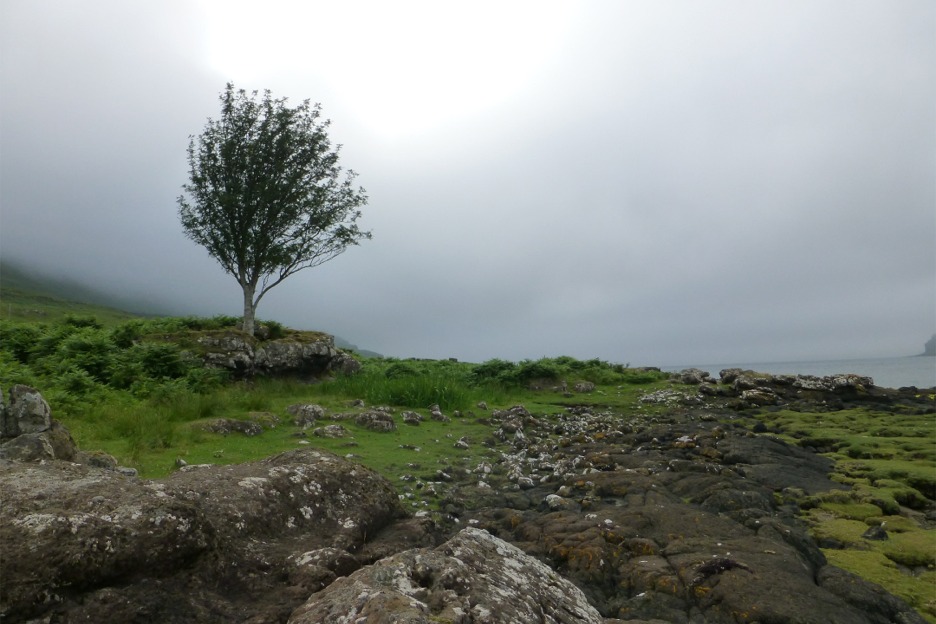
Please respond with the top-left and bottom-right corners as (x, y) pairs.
(201, 0), (575, 139)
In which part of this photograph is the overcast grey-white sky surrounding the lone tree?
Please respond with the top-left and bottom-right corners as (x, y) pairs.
(0, 0), (936, 366)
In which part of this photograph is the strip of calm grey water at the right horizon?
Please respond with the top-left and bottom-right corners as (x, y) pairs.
(663, 357), (936, 388)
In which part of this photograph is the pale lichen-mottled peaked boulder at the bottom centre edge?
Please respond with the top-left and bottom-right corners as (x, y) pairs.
(289, 528), (605, 624)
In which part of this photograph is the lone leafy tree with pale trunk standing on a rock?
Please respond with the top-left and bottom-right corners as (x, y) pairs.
(178, 83), (371, 335)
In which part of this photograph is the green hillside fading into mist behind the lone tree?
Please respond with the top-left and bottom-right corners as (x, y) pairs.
(0, 260), (380, 357)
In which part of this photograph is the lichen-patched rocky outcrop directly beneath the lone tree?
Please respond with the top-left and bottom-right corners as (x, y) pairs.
(195, 329), (361, 376)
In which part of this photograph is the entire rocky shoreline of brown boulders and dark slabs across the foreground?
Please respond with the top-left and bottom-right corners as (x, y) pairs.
(0, 370), (936, 624)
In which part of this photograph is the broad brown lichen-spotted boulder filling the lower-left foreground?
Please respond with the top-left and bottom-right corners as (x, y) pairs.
(0, 449), (402, 623)
